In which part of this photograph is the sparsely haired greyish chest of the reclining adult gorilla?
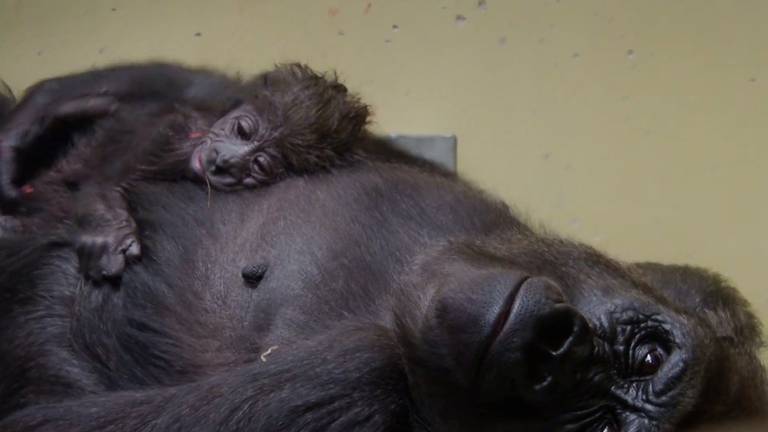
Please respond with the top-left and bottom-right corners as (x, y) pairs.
(117, 167), (519, 364)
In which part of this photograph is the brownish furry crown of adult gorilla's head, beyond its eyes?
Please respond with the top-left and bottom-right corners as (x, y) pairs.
(633, 263), (768, 423)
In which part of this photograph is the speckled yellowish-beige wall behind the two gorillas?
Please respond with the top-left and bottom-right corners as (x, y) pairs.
(0, 0), (768, 344)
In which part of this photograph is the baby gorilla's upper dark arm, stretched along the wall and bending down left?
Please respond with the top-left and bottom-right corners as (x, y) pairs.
(0, 63), (241, 207)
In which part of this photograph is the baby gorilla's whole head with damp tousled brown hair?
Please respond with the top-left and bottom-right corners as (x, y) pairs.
(190, 64), (368, 190)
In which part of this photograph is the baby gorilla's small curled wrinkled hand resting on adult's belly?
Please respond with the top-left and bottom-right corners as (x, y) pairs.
(75, 223), (141, 283)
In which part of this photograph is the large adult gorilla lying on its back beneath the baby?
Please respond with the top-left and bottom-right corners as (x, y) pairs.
(0, 163), (767, 432)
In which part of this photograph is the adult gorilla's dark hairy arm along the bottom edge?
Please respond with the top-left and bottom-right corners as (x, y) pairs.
(0, 325), (410, 432)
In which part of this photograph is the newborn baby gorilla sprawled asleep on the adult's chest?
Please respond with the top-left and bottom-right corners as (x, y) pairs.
(0, 64), (368, 280)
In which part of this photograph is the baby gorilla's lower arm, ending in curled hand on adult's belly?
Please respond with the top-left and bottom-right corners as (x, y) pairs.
(16, 104), (191, 282)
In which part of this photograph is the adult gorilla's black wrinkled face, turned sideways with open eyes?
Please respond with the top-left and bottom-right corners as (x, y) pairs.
(399, 241), (752, 432)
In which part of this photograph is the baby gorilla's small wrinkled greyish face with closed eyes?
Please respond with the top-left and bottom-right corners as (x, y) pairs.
(189, 104), (284, 190)
